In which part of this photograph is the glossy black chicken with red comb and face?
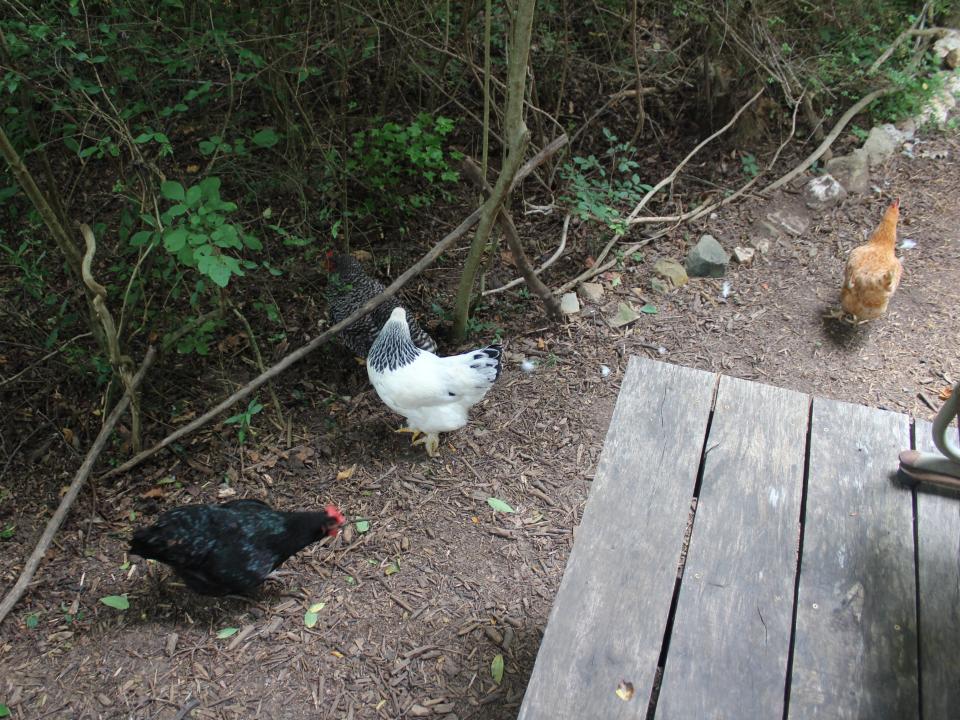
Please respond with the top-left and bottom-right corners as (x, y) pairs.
(130, 499), (346, 595)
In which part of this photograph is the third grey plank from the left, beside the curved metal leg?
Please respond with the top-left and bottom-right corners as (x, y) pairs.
(789, 398), (919, 720)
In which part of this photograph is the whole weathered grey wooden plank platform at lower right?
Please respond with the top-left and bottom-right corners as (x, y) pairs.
(520, 358), (960, 720)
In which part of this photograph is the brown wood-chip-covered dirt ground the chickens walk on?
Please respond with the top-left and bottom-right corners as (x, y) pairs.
(0, 135), (960, 720)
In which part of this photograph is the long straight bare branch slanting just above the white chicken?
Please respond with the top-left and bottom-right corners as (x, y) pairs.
(97, 136), (566, 480)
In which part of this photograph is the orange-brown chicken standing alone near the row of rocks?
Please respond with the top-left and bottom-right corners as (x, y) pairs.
(840, 198), (903, 322)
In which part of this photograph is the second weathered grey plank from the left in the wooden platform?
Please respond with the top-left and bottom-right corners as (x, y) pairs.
(656, 377), (810, 720)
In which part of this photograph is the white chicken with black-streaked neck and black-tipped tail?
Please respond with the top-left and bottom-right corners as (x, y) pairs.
(367, 307), (501, 457)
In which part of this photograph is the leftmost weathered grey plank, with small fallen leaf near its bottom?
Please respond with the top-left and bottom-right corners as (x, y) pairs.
(519, 358), (716, 720)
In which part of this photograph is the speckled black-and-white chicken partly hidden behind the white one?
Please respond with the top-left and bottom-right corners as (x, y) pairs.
(326, 253), (437, 358)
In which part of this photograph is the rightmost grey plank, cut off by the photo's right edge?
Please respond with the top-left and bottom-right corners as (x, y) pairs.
(915, 420), (960, 720)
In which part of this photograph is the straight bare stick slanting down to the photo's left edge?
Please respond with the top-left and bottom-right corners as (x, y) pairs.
(0, 345), (157, 623)
